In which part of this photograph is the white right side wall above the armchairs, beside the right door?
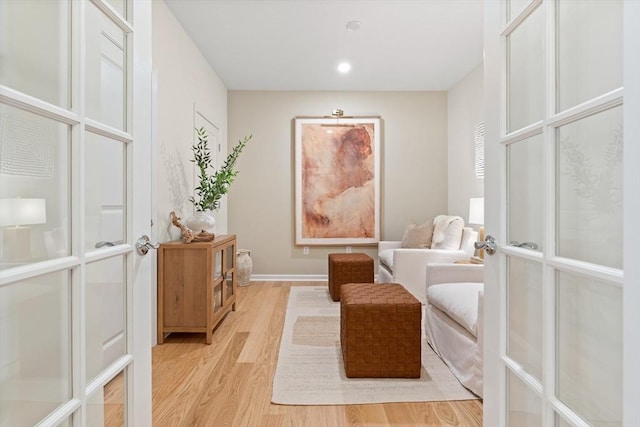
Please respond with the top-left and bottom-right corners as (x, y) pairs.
(447, 64), (484, 223)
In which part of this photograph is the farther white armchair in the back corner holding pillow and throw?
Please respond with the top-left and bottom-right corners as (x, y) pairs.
(377, 227), (478, 304)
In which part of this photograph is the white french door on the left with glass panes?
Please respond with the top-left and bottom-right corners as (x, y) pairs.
(0, 0), (153, 427)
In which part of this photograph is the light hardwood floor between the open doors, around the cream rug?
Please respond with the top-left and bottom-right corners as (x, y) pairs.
(153, 282), (482, 427)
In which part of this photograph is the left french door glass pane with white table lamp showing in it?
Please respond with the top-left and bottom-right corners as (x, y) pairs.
(0, 104), (71, 270)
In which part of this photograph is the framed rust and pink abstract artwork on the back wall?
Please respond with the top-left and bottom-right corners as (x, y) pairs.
(294, 117), (380, 245)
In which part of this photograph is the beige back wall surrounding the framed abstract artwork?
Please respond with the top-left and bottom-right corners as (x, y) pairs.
(229, 91), (447, 275)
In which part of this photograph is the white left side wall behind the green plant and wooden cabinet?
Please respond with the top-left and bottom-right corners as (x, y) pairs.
(153, 0), (227, 242)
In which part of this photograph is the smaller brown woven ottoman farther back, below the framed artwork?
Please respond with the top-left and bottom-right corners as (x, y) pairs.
(329, 253), (373, 301)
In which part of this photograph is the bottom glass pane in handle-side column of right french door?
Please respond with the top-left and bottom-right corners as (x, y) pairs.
(507, 371), (542, 427)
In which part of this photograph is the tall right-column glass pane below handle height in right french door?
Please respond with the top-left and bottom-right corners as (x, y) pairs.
(556, 272), (622, 427)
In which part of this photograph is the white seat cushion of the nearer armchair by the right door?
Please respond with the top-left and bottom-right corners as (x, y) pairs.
(427, 282), (484, 337)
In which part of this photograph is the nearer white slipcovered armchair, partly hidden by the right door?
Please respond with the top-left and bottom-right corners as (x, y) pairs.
(424, 263), (484, 397)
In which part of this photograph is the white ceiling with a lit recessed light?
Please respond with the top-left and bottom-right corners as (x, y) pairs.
(165, 0), (483, 91)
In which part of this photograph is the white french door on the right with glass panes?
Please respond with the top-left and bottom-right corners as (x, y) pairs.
(484, 0), (640, 427)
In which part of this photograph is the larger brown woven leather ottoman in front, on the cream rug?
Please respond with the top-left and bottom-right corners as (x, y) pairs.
(340, 283), (422, 378)
